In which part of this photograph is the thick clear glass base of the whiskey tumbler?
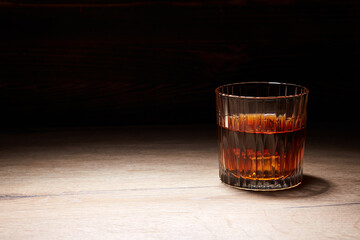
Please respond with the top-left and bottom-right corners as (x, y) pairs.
(220, 169), (302, 191)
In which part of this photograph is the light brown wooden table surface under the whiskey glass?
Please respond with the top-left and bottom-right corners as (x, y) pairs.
(0, 126), (360, 239)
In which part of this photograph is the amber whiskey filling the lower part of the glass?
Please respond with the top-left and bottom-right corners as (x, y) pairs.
(219, 114), (305, 189)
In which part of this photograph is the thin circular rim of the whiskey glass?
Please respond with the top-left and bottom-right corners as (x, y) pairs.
(215, 82), (309, 99)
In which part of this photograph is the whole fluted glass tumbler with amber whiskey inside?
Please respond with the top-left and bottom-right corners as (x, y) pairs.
(215, 82), (309, 190)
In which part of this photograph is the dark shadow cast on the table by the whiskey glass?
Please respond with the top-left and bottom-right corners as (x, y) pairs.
(243, 175), (331, 199)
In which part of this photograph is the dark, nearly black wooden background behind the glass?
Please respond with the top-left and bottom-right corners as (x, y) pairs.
(0, 0), (360, 128)
